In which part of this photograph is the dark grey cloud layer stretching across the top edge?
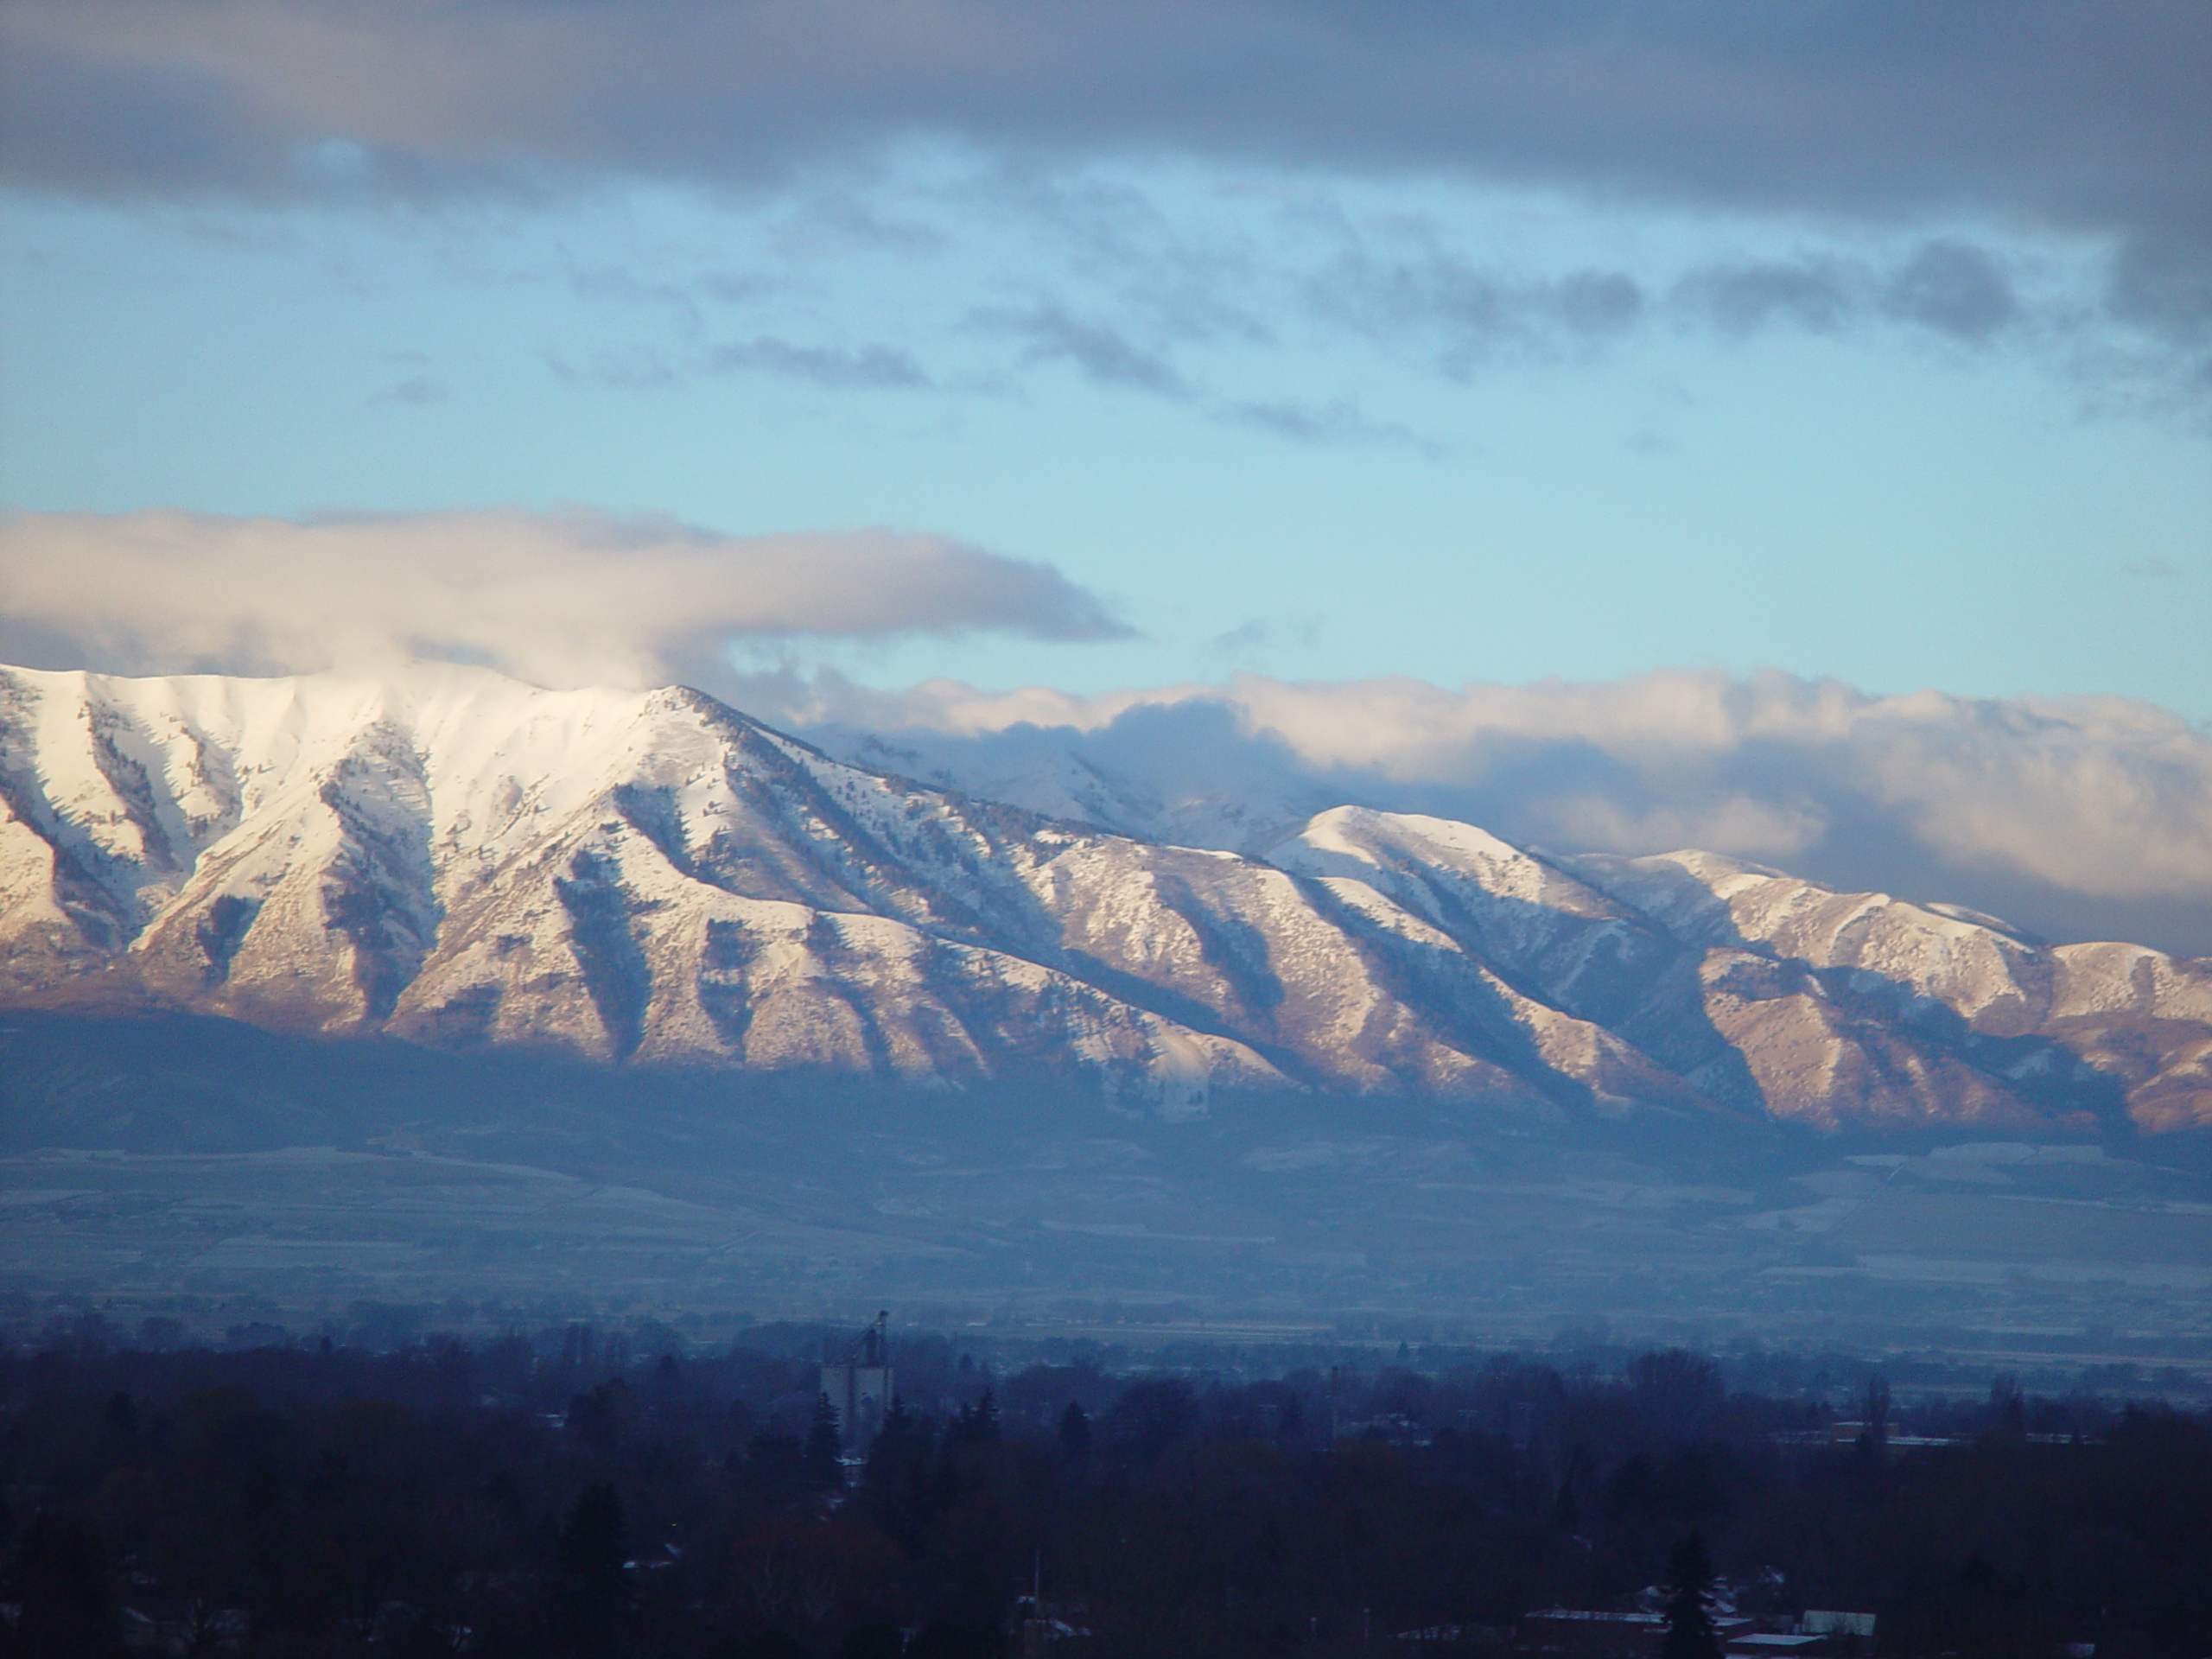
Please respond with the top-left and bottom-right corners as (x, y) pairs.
(0, 0), (2212, 311)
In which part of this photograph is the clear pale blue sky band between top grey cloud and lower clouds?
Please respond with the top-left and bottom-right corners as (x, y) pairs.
(0, 133), (2212, 719)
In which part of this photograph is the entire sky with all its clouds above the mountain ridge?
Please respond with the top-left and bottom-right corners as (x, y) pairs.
(0, 0), (2212, 949)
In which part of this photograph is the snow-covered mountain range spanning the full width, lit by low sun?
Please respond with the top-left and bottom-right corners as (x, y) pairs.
(0, 666), (2212, 1128)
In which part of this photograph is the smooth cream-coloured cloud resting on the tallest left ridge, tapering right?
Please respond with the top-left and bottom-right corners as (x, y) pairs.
(0, 509), (1128, 686)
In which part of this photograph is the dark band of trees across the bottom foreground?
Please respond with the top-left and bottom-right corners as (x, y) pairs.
(0, 1327), (2212, 1659)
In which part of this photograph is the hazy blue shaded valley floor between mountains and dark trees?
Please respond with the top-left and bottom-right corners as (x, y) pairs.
(0, 1024), (2212, 1382)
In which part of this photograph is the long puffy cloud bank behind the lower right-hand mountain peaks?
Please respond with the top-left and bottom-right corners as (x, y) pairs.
(726, 671), (2212, 953)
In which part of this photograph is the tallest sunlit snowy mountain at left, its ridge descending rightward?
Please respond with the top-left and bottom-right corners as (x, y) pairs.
(0, 668), (1645, 1110)
